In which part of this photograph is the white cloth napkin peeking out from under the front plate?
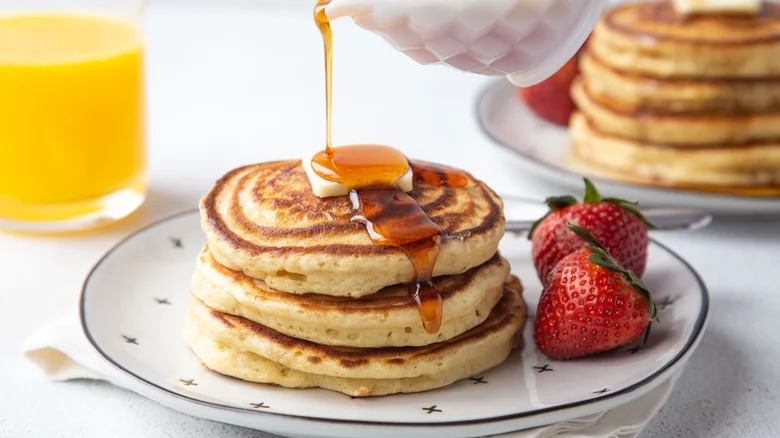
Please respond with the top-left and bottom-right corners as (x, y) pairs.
(24, 315), (680, 438)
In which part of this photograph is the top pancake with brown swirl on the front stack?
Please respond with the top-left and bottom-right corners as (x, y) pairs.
(200, 161), (504, 297)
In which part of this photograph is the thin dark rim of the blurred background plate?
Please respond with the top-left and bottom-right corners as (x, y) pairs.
(474, 78), (780, 202)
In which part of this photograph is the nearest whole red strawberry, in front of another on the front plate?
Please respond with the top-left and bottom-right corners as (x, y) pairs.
(534, 224), (657, 359)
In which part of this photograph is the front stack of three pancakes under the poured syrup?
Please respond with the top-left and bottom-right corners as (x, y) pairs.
(185, 161), (526, 396)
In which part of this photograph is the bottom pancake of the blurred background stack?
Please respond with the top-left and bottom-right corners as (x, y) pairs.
(570, 113), (780, 189)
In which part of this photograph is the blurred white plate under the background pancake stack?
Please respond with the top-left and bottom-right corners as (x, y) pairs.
(477, 80), (780, 215)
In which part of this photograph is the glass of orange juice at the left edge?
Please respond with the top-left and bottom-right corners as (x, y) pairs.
(0, 0), (146, 232)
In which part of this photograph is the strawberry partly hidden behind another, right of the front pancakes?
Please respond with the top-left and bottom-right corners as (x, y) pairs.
(528, 178), (652, 285)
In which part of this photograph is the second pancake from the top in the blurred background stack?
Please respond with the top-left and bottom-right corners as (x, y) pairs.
(580, 51), (780, 114)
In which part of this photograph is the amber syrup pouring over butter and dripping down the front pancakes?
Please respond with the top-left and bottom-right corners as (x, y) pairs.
(311, 0), (468, 333)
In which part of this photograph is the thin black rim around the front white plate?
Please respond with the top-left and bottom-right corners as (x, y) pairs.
(79, 210), (710, 428)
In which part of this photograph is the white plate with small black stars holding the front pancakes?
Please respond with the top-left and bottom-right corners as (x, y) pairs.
(81, 211), (708, 438)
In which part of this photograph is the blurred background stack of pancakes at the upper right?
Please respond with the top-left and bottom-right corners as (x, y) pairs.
(571, 2), (780, 188)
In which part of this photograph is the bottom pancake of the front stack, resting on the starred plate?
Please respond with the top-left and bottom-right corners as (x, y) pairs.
(185, 278), (526, 396)
